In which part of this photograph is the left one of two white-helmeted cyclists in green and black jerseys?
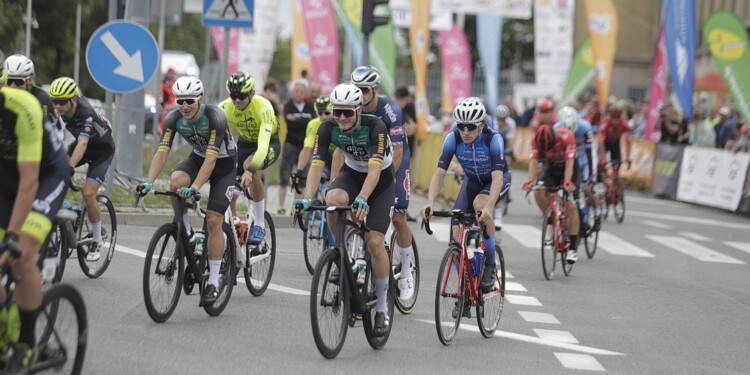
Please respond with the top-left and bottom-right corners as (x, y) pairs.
(138, 76), (237, 305)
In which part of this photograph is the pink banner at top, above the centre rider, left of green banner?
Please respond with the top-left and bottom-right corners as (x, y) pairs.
(302, 0), (339, 94)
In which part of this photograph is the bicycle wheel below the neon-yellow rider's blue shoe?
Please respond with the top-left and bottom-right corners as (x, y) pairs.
(244, 211), (276, 297)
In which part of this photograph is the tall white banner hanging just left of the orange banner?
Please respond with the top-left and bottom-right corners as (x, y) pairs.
(534, 0), (575, 99)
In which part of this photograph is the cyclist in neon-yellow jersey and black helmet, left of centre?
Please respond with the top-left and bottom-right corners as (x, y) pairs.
(219, 72), (281, 244)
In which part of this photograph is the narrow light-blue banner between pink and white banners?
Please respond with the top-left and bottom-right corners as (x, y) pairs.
(477, 14), (503, 114)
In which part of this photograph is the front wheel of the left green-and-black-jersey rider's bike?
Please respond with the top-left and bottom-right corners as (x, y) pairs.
(143, 223), (185, 323)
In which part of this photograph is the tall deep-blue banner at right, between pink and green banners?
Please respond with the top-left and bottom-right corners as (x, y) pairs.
(664, 0), (696, 120)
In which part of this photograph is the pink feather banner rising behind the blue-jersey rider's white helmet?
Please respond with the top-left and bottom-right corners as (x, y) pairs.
(438, 22), (472, 108)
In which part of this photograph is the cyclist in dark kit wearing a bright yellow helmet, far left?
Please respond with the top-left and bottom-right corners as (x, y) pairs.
(49, 77), (115, 262)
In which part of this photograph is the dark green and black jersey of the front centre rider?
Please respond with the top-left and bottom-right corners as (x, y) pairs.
(312, 114), (393, 173)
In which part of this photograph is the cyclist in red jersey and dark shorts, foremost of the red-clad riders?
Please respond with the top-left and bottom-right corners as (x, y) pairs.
(523, 125), (580, 264)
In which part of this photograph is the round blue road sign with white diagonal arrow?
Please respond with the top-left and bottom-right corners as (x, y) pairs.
(86, 21), (159, 94)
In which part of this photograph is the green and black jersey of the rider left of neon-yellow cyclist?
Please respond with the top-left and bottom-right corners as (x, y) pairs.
(158, 104), (237, 158)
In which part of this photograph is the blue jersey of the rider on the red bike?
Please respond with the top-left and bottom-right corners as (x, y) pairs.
(438, 130), (508, 183)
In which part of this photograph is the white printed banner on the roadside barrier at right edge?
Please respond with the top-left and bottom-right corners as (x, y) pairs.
(677, 147), (750, 211)
